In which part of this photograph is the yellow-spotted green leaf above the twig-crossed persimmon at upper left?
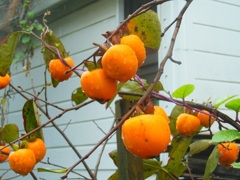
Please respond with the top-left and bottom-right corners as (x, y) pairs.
(43, 32), (68, 68)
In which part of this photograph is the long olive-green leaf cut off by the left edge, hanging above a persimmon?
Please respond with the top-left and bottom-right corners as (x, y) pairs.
(0, 32), (22, 75)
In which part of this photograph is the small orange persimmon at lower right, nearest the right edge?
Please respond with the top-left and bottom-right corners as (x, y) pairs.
(218, 142), (239, 167)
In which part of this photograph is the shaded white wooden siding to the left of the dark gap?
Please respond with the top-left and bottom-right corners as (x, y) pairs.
(0, 0), (123, 179)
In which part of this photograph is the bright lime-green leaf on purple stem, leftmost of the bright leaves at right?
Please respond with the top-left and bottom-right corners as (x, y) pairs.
(172, 84), (194, 99)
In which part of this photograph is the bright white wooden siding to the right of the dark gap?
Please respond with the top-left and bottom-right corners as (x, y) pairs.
(159, 0), (240, 130)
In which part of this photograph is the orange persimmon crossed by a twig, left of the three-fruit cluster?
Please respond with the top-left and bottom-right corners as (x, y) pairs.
(48, 58), (74, 82)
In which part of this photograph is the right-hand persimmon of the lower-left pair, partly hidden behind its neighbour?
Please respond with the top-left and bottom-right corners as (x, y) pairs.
(27, 138), (47, 162)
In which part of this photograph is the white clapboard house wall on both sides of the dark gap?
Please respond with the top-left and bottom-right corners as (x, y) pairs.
(0, 0), (240, 180)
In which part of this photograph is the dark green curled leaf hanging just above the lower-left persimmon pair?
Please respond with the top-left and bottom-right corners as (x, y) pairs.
(22, 99), (43, 139)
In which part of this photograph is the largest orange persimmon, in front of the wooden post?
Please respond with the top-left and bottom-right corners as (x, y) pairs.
(122, 114), (171, 159)
